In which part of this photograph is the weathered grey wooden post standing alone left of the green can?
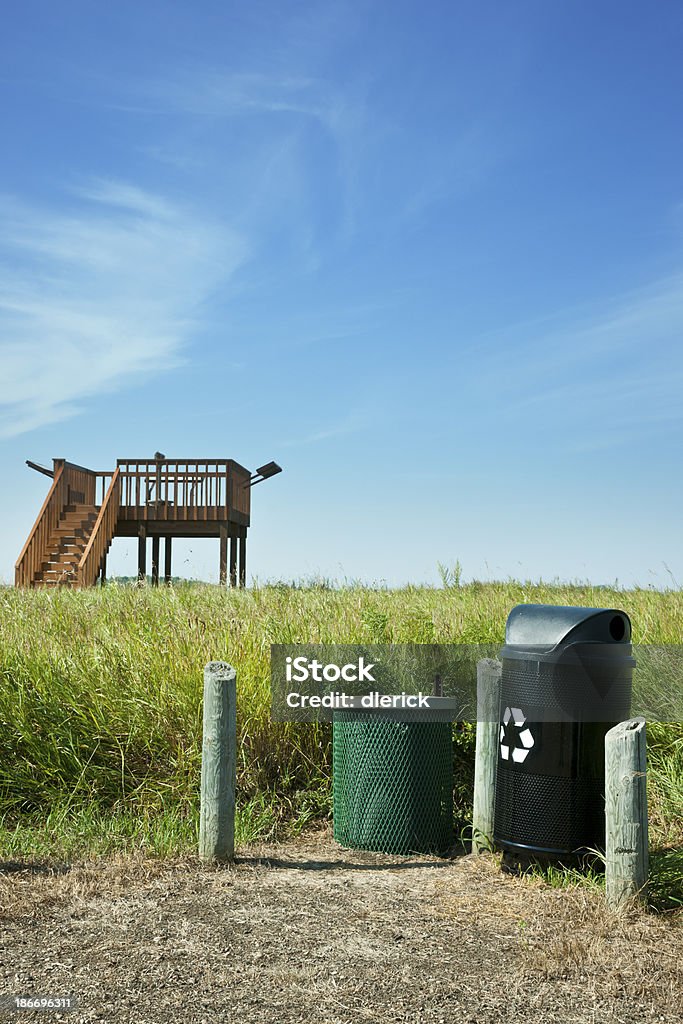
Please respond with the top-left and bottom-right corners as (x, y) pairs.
(200, 662), (237, 860)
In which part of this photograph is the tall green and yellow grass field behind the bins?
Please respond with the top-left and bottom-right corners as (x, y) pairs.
(0, 572), (683, 905)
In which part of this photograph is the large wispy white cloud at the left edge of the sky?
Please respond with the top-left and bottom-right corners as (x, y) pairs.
(0, 179), (249, 437)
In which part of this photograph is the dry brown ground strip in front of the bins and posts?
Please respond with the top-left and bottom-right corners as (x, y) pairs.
(0, 831), (683, 1024)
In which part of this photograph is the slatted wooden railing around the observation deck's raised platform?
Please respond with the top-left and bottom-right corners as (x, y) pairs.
(117, 459), (251, 521)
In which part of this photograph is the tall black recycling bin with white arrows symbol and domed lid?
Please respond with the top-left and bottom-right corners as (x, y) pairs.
(494, 604), (635, 868)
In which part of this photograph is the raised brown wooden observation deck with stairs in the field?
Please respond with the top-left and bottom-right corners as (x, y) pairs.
(14, 456), (272, 587)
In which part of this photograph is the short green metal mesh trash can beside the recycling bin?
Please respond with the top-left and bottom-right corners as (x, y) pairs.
(332, 697), (456, 854)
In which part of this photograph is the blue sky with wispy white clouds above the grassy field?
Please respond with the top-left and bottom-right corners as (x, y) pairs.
(0, 0), (683, 587)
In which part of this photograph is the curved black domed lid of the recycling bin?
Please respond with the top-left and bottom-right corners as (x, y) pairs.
(505, 604), (631, 651)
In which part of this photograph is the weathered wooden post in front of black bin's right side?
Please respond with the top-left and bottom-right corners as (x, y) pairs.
(605, 718), (647, 910)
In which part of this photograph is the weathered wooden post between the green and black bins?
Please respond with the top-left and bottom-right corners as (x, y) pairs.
(472, 657), (503, 853)
